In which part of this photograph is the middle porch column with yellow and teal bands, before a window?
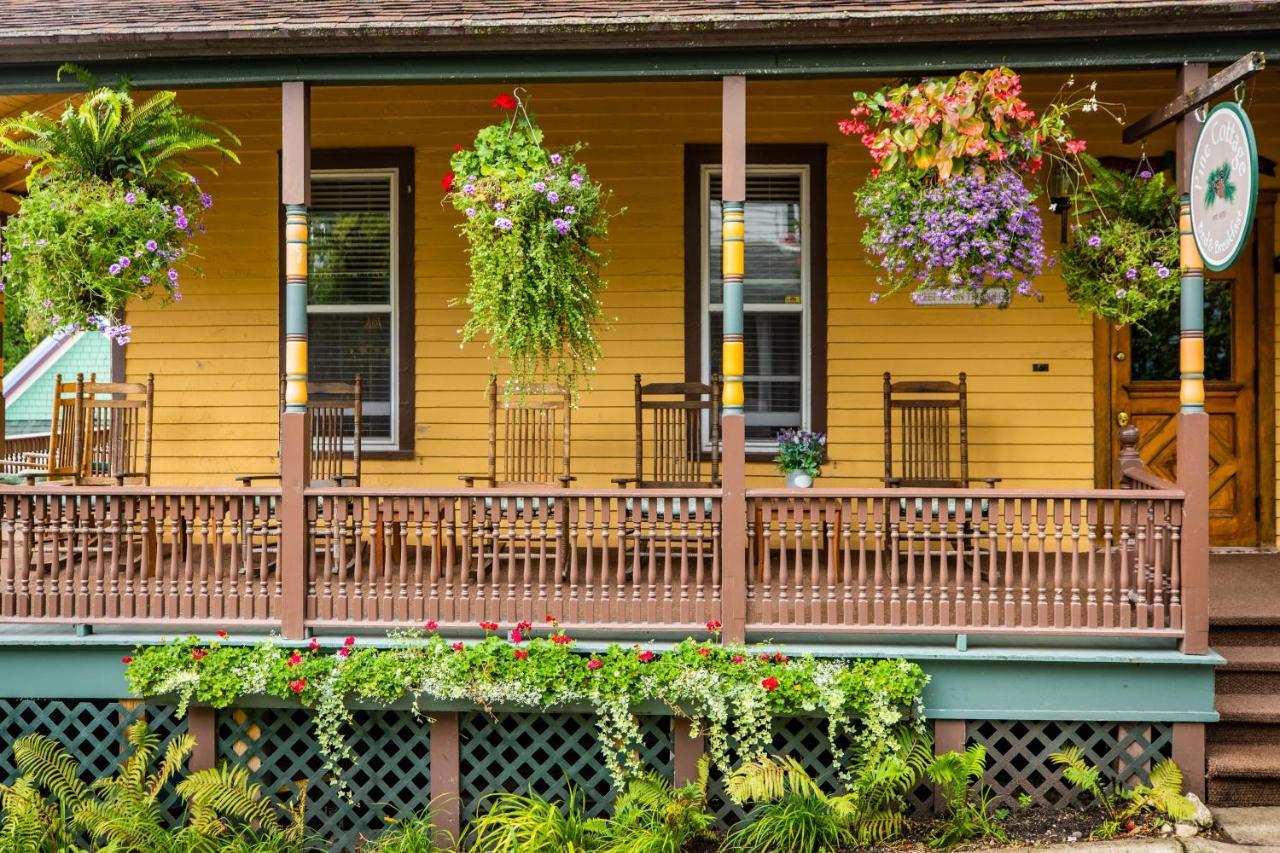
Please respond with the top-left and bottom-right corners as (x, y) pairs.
(721, 77), (746, 643)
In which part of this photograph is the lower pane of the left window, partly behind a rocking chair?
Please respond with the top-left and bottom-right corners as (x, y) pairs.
(307, 311), (394, 442)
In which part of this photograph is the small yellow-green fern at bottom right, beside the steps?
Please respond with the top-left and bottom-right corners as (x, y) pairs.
(1050, 745), (1196, 839)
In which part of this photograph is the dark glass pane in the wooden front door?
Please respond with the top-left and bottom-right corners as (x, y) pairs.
(1129, 279), (1233, 382)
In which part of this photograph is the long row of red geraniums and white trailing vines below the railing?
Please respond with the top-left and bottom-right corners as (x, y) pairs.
(125, 620), (928, 790)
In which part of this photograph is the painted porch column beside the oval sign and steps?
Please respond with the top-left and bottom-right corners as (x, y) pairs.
(1176, 63), (1208, 654)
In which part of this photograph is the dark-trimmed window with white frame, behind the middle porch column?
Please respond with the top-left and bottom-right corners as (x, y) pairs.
(686, 146), (826, 452)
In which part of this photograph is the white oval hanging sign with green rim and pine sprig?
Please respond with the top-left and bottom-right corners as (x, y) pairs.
(1190, 102), (1258, 272)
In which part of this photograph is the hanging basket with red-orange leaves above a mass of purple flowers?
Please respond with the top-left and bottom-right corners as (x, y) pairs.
(838, 68), (1105, 307)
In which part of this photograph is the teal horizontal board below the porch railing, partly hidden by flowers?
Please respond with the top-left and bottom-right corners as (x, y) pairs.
(0, 637), (1225, 722)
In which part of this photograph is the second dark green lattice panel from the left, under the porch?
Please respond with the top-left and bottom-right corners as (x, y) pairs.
(218, 708), (431, 849)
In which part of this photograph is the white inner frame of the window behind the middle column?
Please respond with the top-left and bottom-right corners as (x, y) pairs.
(699, 164), (813, 452)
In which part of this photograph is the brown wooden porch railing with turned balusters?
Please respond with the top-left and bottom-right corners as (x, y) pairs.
(0, 485), (1187, 639)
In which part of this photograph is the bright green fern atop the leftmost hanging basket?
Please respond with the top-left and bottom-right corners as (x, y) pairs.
(0, 63), (239, 187)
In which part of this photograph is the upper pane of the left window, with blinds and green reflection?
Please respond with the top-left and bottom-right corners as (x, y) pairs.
(307, 174), (392, 305)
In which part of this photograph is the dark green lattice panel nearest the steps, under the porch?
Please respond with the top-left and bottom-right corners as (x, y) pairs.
(966, 721), (1172, 808)
